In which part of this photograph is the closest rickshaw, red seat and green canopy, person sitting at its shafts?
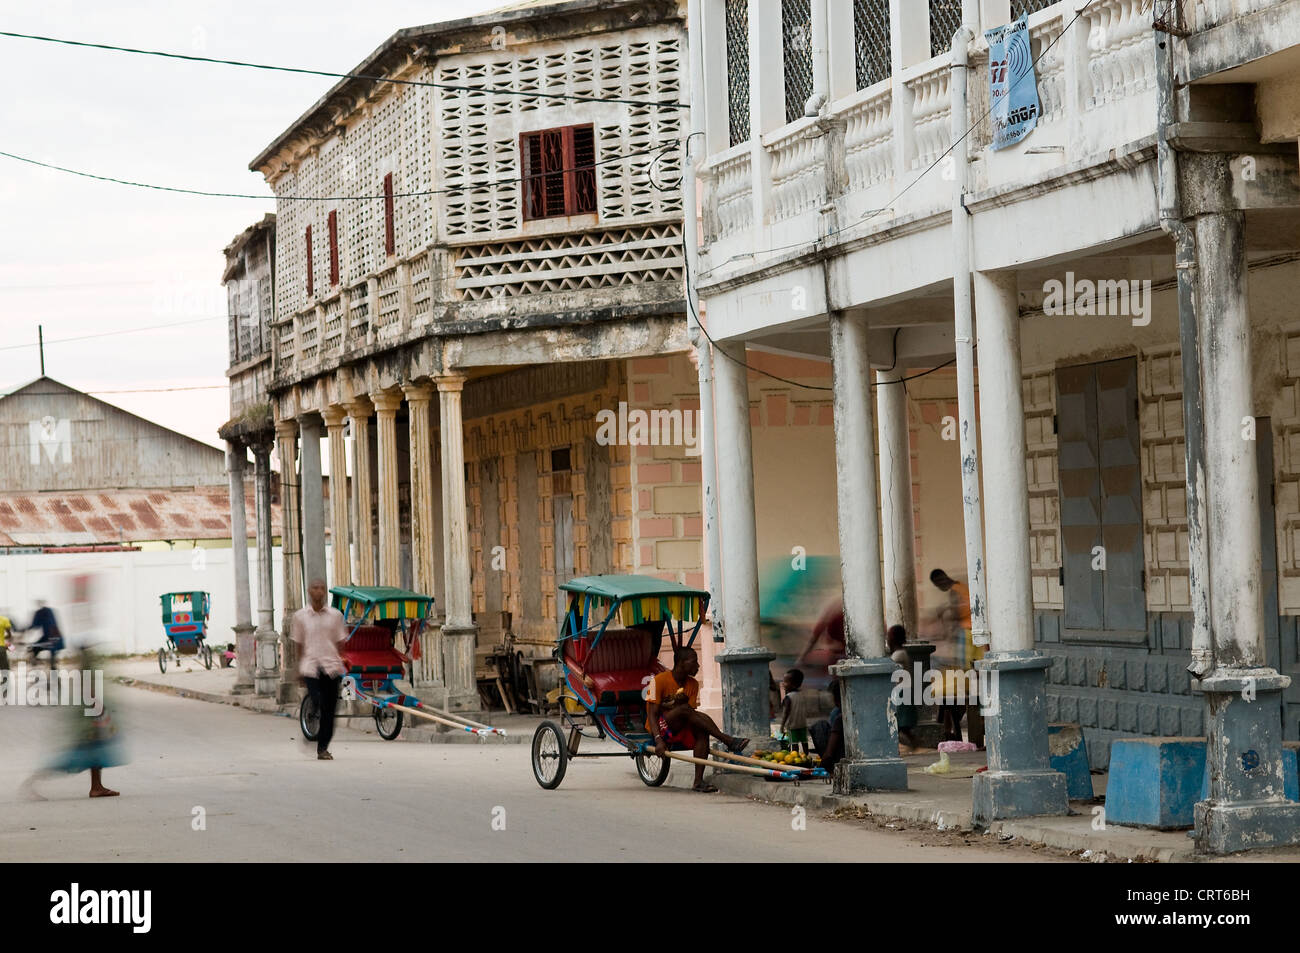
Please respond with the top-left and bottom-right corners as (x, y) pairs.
(532, 575), (826, 790)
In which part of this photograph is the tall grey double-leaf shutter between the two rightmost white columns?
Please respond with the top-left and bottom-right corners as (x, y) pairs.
(1056, 358), (1147, 641)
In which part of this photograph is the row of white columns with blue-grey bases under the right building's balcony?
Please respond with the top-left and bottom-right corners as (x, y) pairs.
(715, 211), (1300, 853)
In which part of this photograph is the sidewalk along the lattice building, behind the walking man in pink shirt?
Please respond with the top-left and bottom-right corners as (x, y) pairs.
(112, 657), (546, 745)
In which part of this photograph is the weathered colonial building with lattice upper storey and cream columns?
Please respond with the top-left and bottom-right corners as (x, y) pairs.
(251, 0), (703, 709)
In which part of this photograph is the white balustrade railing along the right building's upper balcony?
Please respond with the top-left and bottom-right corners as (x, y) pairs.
(699, 0), (1170, 274)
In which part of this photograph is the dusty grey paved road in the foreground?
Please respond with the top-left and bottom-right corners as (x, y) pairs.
(0, 686), (1048, 862)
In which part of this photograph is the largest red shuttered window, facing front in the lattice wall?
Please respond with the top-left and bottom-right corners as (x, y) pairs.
(519, 126), (595, 221)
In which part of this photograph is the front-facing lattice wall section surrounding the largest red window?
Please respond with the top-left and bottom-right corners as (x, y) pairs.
(436, 26), (686, 299)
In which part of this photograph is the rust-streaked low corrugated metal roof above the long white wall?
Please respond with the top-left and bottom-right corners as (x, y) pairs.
(0, 486), (281, 546)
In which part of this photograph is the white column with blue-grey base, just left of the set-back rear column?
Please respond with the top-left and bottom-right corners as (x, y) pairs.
(831, 313), (907, 793)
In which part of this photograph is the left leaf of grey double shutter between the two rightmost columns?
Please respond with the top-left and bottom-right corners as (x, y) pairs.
(1056, 364), (1104, 629)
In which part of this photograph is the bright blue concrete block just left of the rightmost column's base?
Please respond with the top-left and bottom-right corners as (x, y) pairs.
(1106, 737), (1205, 831)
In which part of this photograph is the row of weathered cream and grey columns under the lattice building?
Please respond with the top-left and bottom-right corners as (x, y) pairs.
(229, 376), (478, 710)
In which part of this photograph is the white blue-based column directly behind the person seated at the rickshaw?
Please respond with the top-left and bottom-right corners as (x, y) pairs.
(714, 340), (774, 738)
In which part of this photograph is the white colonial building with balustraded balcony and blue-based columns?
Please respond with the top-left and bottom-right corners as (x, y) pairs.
(692, 0), (1300, 850)
